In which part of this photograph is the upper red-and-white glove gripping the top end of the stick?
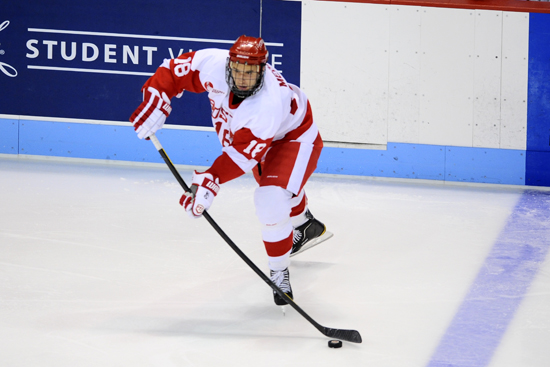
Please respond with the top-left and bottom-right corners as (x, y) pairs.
(130, 87), (172, 139)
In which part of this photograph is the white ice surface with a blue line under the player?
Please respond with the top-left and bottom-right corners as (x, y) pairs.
(0, 156), (550, 367)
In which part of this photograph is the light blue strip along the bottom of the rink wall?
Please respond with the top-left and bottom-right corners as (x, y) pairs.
(0, 119), (526, 185)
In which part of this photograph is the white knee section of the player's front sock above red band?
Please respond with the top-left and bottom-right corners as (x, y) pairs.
(254, 186), (292, 225)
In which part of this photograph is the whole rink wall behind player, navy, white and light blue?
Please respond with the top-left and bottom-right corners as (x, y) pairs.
(0, 0), (550, 186)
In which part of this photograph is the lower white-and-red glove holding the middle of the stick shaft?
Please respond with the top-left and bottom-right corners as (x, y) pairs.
(180, 171), (220, 218)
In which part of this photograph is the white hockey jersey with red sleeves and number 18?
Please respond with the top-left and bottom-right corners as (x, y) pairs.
(145, 49), (322, 183)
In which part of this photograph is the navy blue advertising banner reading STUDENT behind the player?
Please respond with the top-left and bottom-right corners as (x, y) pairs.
(0, 0), (301, 126)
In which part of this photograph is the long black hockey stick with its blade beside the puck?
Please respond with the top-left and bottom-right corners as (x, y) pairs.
(150, 134), (362, 343)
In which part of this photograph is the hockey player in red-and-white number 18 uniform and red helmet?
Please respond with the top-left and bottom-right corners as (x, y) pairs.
(130, 36), (329, 305)
